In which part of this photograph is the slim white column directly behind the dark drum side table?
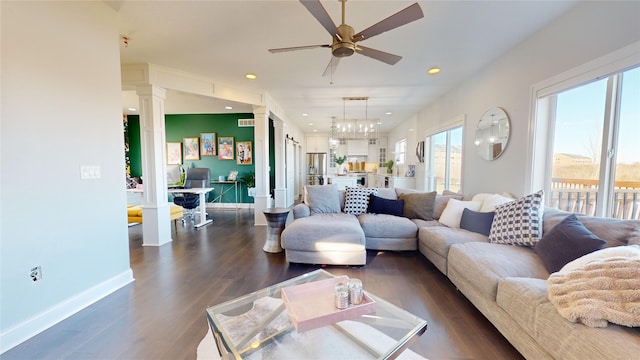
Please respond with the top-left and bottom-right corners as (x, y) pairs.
(253, 106), (271, 226)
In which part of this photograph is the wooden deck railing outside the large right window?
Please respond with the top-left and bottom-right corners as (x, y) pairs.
(549, 178), (640, 220)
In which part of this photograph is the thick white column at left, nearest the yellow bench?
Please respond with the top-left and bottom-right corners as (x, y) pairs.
(136, 85), (171, 246)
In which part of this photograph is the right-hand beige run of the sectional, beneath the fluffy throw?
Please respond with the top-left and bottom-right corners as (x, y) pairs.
(418, 204), (640, 359)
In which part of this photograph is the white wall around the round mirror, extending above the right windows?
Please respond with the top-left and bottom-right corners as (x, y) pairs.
(398, 1), (640, 195)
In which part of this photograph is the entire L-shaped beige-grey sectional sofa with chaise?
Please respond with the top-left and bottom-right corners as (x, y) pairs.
(282, 184), (640, 360)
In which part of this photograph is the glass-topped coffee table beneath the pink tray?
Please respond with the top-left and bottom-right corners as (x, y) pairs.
(207, 269), (427, 360)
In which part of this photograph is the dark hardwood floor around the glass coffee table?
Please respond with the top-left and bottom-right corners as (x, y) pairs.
(5, 209), (522, 360)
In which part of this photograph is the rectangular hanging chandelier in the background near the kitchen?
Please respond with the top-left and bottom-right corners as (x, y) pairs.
(338, 97), (378, 140)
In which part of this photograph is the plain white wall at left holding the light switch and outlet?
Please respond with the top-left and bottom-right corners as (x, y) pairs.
(0, 1), (133, 352)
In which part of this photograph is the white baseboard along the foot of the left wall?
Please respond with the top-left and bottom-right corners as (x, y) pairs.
(0, 269), (135, 354)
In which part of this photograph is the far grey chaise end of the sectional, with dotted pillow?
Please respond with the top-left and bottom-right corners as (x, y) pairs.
(281, 185), (424, 265)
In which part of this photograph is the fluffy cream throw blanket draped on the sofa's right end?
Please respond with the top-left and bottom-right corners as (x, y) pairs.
(547, 257), (640, 327)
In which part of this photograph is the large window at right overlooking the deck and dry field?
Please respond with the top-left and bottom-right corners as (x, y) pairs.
(538, 67), (640, 219)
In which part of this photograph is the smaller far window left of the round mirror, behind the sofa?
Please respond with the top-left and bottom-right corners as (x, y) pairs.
(424, 126), (462, 193)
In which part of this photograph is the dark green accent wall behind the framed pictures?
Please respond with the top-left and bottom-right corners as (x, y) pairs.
(127, 113), (255, 203)
